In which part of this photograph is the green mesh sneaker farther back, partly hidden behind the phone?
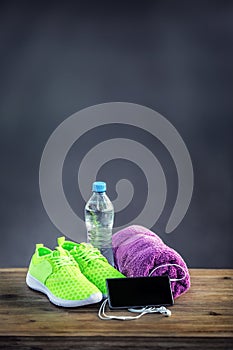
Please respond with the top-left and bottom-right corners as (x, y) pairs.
(57, 237), (125, 297)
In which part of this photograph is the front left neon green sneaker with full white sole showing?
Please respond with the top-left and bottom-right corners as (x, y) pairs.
(26, 244), (102, 307)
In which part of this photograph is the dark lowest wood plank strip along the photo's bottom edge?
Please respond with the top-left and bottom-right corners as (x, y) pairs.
(0, 336), (232, 350)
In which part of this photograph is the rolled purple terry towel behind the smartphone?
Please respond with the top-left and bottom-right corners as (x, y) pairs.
(112, 225), (190, 298)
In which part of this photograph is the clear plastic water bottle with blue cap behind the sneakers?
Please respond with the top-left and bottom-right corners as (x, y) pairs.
(85, 181), (114, 265)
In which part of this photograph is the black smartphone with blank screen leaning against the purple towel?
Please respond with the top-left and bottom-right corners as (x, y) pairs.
(106, 276), (174, 309)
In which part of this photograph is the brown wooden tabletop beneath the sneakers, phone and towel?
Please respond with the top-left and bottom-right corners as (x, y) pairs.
(0, 269), (233, 349)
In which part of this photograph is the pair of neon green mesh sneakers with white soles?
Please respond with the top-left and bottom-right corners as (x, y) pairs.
(26, 237), (124, 307)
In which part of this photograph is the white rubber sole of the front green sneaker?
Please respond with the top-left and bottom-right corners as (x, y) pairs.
(26, 272), (103, 307)
